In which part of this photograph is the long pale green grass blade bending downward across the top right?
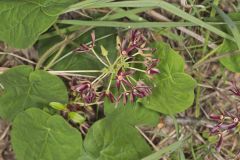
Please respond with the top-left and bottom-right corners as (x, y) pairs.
(64, 0), (235, 41)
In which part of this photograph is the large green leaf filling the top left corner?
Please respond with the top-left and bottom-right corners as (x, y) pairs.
(0, 0), (76, 48)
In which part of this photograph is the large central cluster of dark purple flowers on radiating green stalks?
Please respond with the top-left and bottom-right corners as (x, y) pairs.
(71, 30), (160, 105)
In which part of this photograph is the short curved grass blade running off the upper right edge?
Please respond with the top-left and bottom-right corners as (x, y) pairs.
(214, 6), (240, 49)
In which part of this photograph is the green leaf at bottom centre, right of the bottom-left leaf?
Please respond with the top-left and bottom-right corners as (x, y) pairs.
(84, 119), (151, 160)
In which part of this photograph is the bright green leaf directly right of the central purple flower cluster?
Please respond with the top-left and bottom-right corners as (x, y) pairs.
(143, 43), (196, 114)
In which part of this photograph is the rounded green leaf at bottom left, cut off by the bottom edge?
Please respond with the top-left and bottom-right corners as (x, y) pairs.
(11, 108), (83, 160)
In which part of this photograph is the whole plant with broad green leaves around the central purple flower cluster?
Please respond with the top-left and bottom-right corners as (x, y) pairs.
(0, 0), (211, 160)
